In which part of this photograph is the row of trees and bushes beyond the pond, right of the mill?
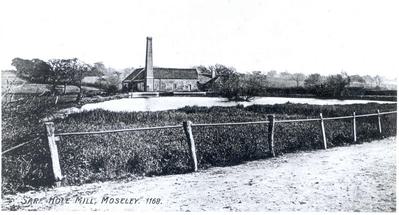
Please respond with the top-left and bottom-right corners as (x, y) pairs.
(198, 64), (390, 101)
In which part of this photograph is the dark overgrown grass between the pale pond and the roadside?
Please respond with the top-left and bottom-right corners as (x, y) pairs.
(2, 103), (396, 193)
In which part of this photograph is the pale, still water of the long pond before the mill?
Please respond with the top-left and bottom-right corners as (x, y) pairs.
(43, 94), (396, 121)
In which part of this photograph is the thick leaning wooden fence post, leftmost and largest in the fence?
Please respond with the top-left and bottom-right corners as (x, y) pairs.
(45, 122), (62, 187)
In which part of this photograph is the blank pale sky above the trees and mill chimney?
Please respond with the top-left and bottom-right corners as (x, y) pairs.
(0, 0), (399, 77)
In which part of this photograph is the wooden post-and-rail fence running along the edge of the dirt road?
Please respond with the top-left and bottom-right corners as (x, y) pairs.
(2, 110), (397, 186)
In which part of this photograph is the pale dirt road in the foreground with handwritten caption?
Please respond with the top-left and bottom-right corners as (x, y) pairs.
(2, 138), (396, 211)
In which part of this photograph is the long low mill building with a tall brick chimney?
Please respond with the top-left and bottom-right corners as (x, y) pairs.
(122, 37), (212, 92)
